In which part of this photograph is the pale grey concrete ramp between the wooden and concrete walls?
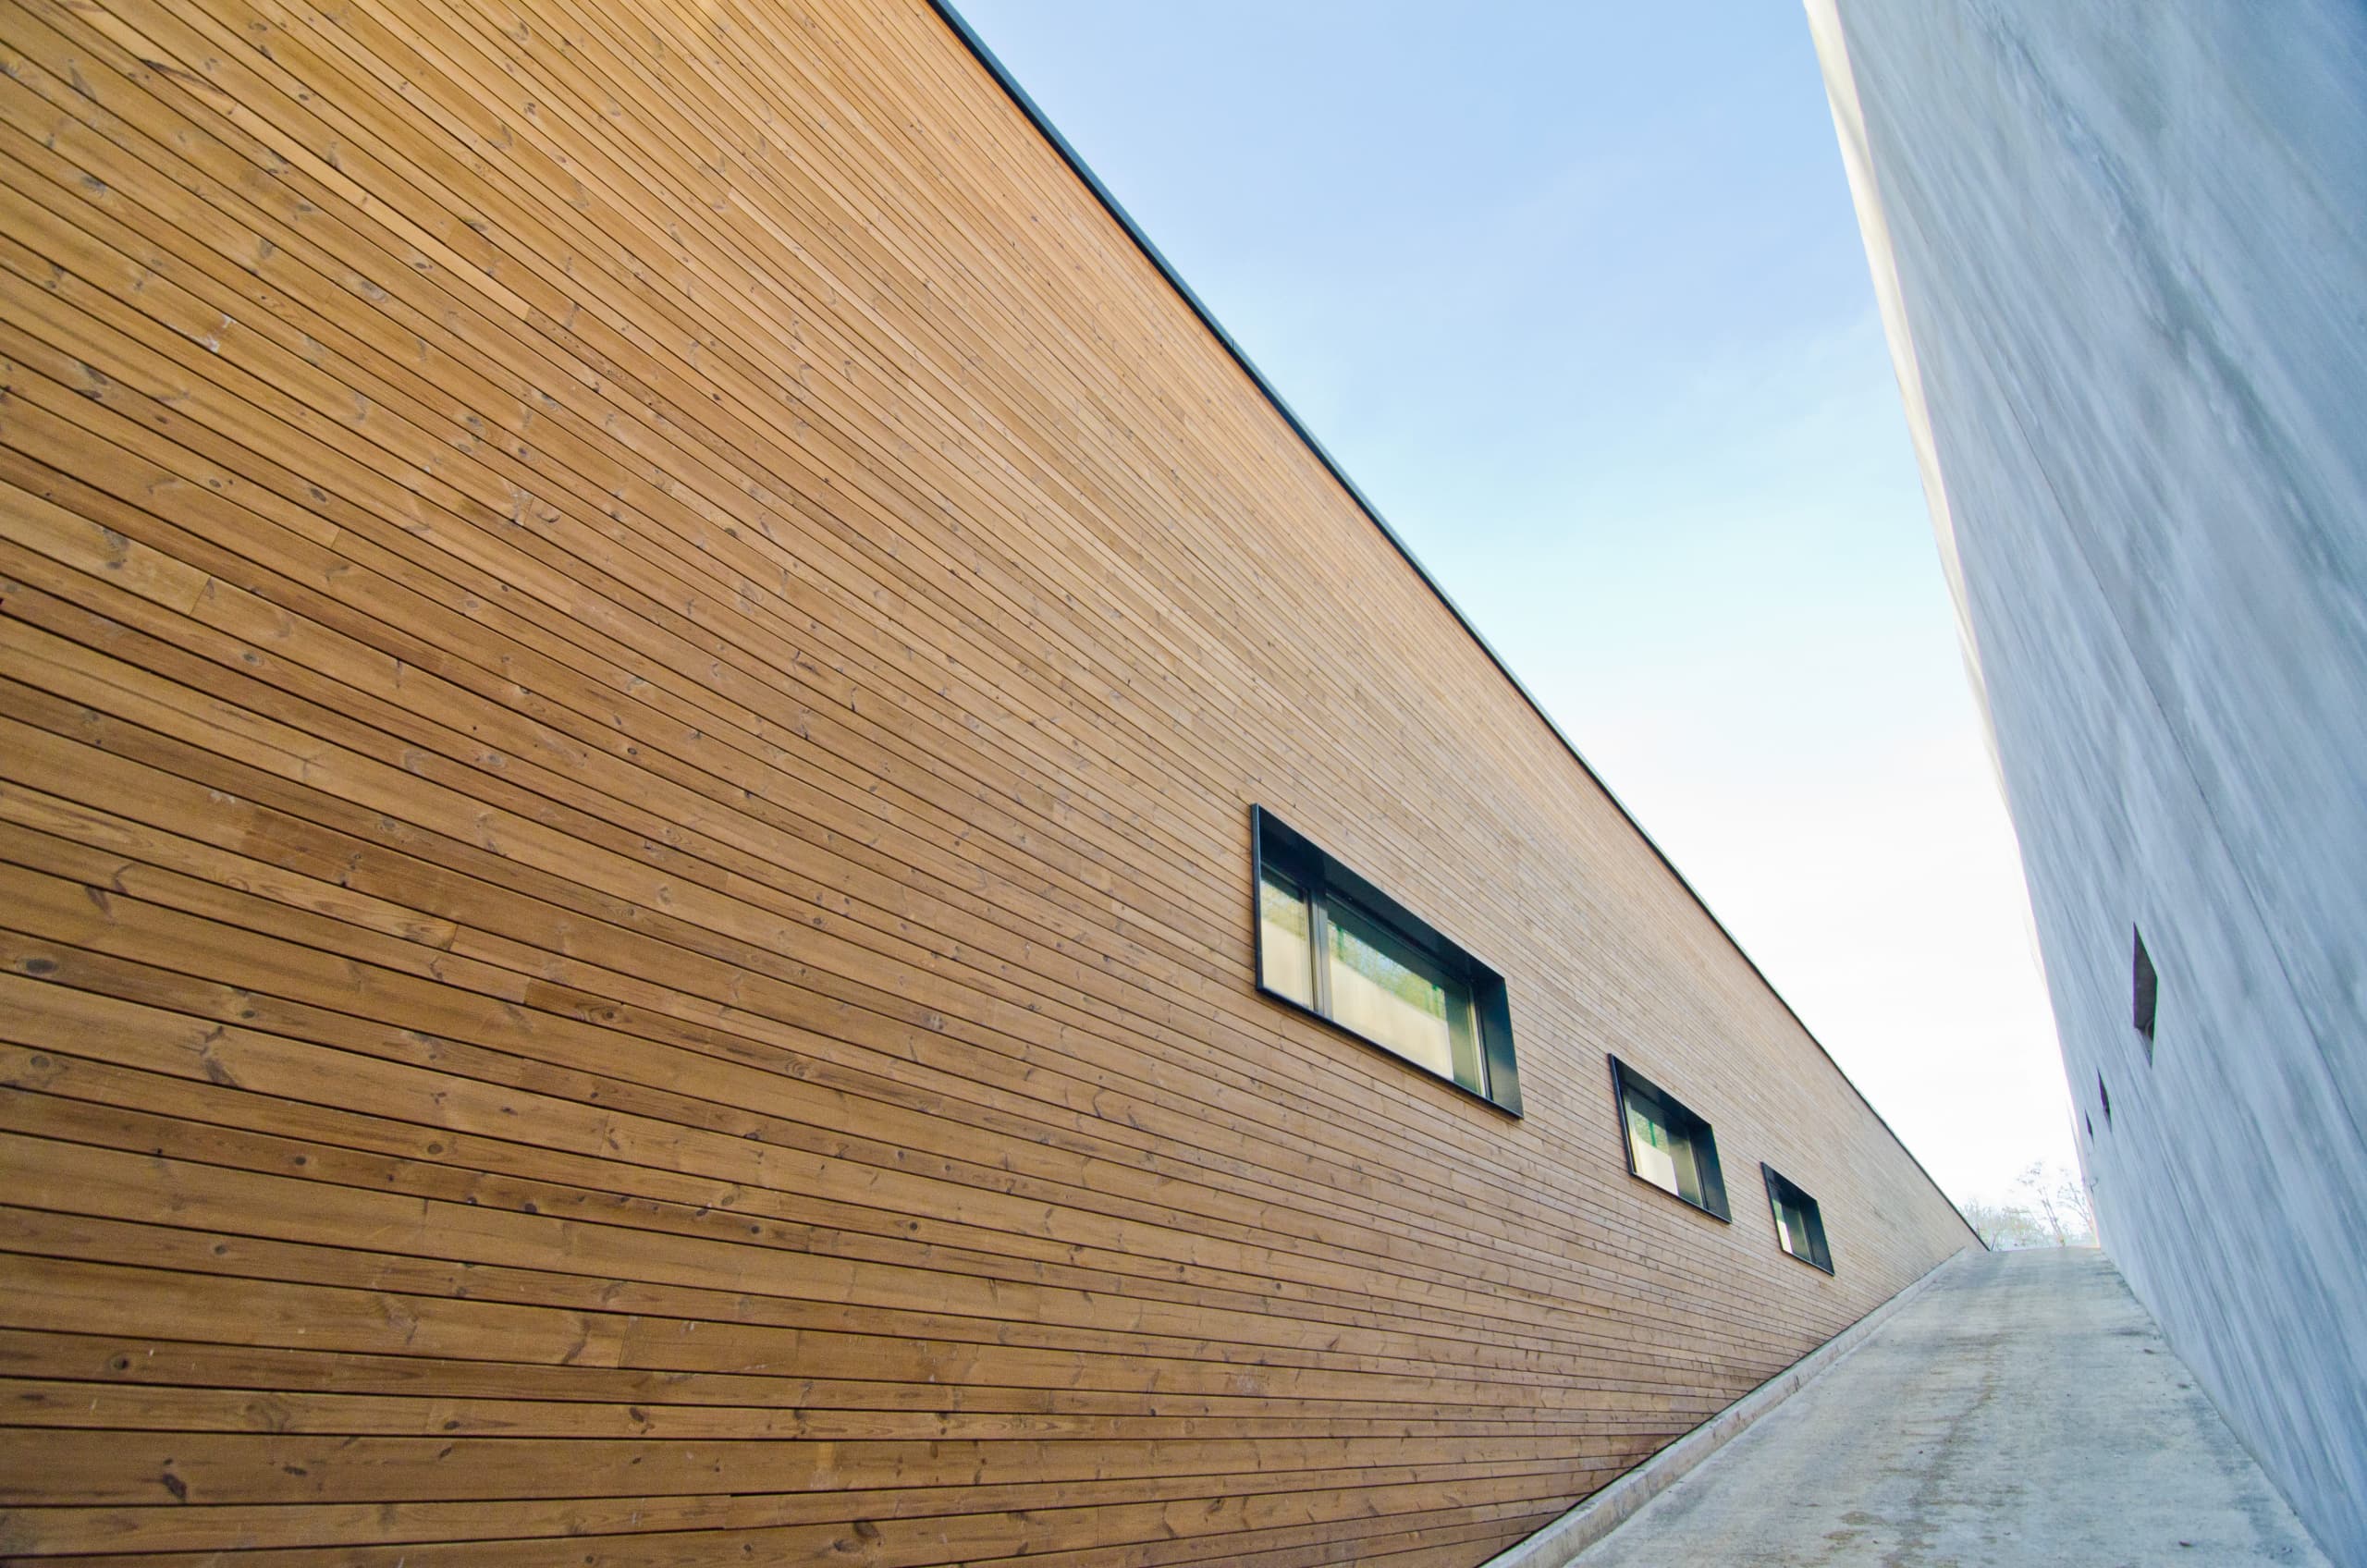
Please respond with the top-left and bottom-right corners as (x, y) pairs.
(1576, 1248), (2326, 1568)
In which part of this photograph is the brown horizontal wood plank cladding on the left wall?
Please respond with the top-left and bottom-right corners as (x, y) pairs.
(0, 0), (1969, 1568)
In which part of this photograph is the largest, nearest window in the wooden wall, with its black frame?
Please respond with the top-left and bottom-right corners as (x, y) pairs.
(1250, 808), (1520, 1116)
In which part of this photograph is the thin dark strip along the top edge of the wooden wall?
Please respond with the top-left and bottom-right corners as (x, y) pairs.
(928, 0), (1979, 1241)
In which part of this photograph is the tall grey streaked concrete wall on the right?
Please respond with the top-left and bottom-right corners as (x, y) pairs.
(1809, 0), (2367, 1563)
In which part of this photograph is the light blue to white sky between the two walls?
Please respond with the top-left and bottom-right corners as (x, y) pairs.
(961, 0), (2074, 1201)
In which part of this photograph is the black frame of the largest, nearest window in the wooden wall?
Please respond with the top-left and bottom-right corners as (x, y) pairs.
(1250, 805), (1520, 1116)
